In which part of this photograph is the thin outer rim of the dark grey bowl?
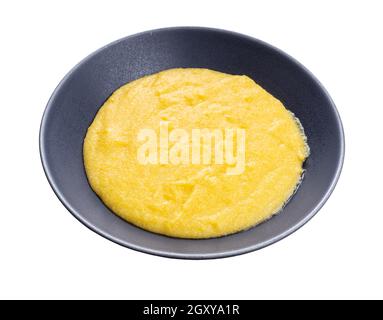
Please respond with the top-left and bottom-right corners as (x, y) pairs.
(39, 26), (345, 260)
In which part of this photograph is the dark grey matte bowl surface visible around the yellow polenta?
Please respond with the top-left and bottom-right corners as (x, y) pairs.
(40, 27), (344, 259)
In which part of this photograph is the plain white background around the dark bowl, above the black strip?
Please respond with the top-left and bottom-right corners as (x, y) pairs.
(0, 0), (383, 299)
